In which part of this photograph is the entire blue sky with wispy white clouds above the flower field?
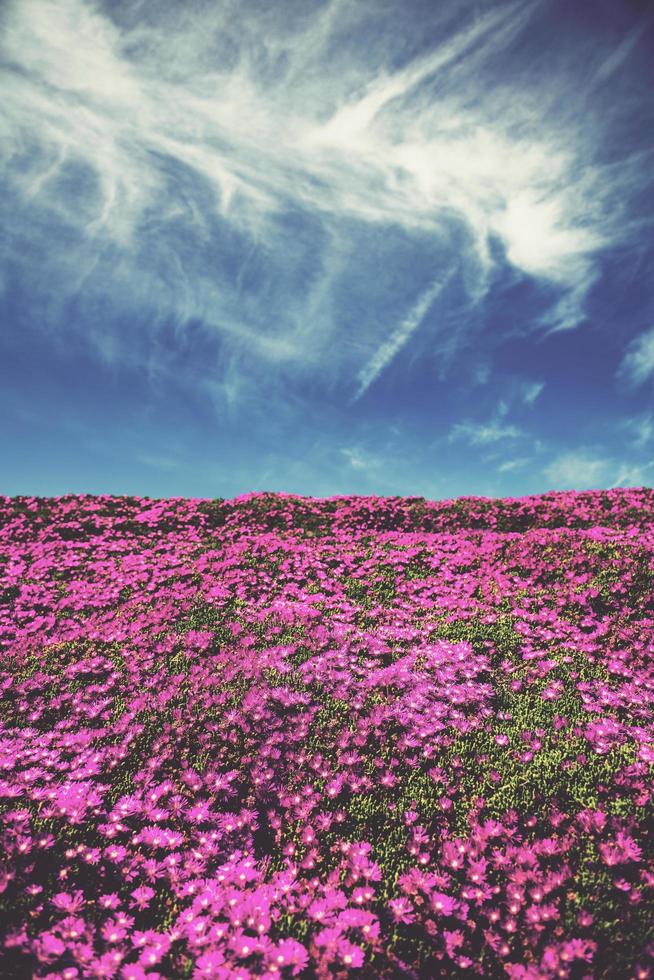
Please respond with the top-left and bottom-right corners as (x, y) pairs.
(0, 0), (654, 499)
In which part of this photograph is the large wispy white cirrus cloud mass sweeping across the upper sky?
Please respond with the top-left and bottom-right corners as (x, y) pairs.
(0, 0), (649, 408)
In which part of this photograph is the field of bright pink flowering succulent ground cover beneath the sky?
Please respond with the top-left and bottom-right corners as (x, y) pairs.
(0, 490), (654, 980)
